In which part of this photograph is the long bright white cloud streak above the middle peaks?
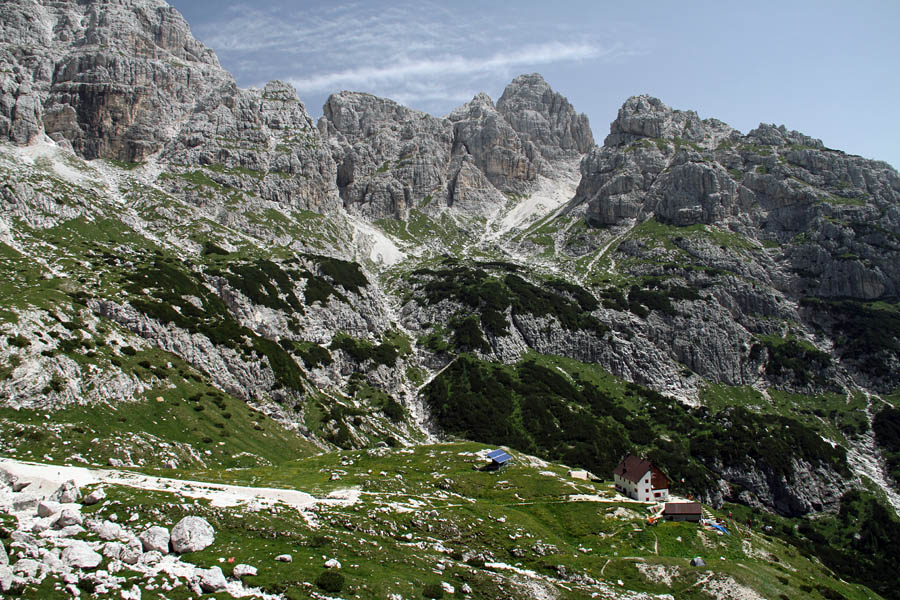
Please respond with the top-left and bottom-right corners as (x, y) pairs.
(288, 42), (618, 92)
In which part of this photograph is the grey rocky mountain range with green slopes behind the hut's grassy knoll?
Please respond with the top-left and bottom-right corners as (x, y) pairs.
(0, 0), (900, 592)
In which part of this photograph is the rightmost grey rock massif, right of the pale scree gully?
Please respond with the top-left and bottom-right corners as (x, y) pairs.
(575, 96), (900, 300)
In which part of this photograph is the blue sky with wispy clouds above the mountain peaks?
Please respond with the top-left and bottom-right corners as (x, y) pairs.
(170, 0), (900, 167)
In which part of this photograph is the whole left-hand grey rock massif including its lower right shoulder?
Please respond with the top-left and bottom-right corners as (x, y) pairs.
(0, 0), (337, 212)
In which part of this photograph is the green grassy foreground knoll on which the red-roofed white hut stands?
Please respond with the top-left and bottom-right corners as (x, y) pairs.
(3, 443), (877, 600)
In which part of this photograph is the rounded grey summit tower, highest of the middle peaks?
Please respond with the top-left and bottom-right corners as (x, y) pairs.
(497, 73), (594, 160)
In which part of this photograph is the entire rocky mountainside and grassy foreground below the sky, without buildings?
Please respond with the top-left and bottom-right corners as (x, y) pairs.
(0, 0), (900, 600)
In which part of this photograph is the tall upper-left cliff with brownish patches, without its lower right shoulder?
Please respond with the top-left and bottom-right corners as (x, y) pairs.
(0, 0), (231, 161)
